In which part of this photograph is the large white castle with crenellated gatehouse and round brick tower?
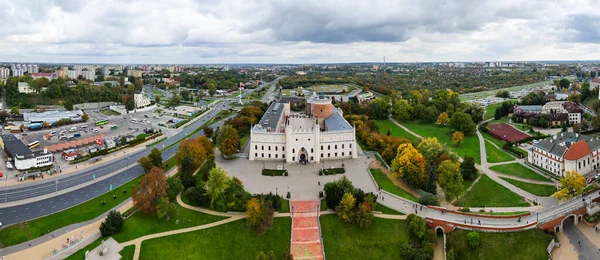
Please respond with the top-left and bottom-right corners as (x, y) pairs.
(249, 96), (357, 163)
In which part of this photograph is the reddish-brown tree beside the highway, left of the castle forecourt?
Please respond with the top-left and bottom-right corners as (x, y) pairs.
(132, 167), (169, 214)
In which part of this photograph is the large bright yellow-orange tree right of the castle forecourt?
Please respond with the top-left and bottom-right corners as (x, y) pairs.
(392, 143), (427, 188)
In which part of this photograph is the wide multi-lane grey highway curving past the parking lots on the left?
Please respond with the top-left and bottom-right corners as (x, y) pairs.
(0, 76), (277, 226)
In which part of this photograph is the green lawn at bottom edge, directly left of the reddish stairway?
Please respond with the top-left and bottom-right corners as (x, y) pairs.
(140, 217), (292, 259)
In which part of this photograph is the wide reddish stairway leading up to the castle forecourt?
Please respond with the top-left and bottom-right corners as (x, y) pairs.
(290, 200), (325, 259)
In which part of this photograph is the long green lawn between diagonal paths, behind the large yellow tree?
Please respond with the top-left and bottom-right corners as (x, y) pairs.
(402, 122), (481, 164)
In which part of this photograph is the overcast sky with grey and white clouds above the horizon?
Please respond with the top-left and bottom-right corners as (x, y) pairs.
(0, 0), (600, 63)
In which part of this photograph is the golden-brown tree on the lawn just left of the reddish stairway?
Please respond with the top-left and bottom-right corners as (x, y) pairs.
(246, 198), (274, 234)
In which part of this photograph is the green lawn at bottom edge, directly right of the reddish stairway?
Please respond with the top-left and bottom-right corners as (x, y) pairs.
(320, 215), (411, 260)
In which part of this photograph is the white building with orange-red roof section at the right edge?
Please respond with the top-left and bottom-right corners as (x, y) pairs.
(527, 132), (600, 176)
